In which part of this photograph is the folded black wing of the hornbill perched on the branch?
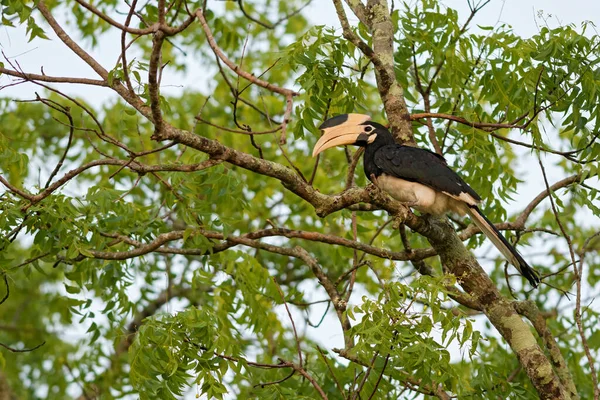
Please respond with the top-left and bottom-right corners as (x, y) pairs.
(374, 144), (481, 201)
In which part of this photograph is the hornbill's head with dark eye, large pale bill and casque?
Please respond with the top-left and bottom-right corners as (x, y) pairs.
(313, 114), (391, 157)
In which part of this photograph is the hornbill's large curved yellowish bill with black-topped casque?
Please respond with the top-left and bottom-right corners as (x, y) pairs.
(313, 114), (371, 157)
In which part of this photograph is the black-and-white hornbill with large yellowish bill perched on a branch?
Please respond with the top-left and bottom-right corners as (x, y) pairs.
(313, 114), (540, 287)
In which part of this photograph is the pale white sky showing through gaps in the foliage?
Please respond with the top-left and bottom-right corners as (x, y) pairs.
(0, 0), (600, 396)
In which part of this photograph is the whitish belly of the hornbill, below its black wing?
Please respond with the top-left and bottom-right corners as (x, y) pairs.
(375, 175), (467, 215)
